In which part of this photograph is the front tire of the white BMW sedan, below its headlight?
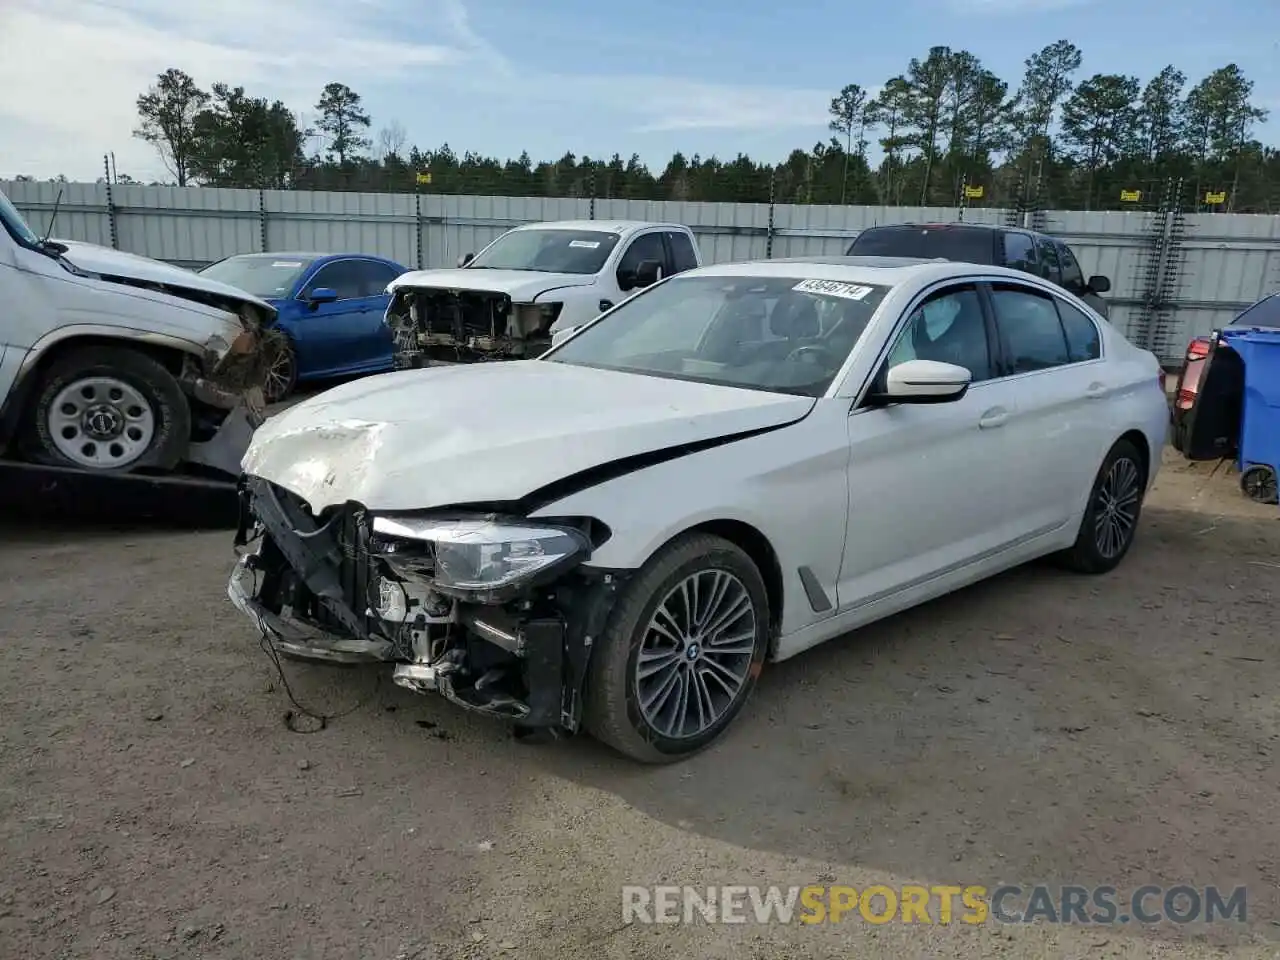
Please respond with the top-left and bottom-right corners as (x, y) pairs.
(582, 534), (771, 764)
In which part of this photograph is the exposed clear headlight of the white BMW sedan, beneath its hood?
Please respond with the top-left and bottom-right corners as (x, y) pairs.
(374, 516), (591, 602)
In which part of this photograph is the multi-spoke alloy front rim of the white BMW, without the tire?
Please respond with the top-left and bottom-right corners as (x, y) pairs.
(635, 570), (758, 740)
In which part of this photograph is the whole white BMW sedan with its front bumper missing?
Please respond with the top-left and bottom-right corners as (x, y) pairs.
(228, 257), (1169, 763)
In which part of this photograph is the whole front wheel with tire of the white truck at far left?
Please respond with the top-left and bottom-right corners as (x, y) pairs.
(26, 347), (191, 474)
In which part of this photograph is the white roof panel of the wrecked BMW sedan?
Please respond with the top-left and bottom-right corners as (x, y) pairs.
(676, 256), (1047, 287)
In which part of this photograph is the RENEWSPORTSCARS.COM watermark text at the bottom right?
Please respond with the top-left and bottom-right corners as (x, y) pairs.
(622, 884), (1247, 925)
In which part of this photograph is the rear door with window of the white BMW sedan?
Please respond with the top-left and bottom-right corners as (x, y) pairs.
(988, 282), (1114, 538)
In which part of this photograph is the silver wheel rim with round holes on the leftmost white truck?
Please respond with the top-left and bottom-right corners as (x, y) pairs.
(46, 376), (156, 470)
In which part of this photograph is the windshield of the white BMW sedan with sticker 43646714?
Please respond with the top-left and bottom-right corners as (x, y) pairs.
(544, 276), (890, 397)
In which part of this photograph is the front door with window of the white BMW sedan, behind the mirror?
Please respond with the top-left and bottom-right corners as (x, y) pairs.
(838, 283), (1019, 609)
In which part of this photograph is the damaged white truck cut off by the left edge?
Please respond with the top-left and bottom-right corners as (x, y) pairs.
(0, 185), (278, 476)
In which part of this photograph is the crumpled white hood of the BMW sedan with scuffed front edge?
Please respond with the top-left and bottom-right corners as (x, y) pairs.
(242, 360), (815, 513)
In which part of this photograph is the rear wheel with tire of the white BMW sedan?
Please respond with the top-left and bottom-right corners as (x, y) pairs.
(1060, 440), (1147, 573)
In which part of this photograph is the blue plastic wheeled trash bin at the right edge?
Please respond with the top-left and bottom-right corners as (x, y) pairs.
(1222, 328), (1280, 503)
